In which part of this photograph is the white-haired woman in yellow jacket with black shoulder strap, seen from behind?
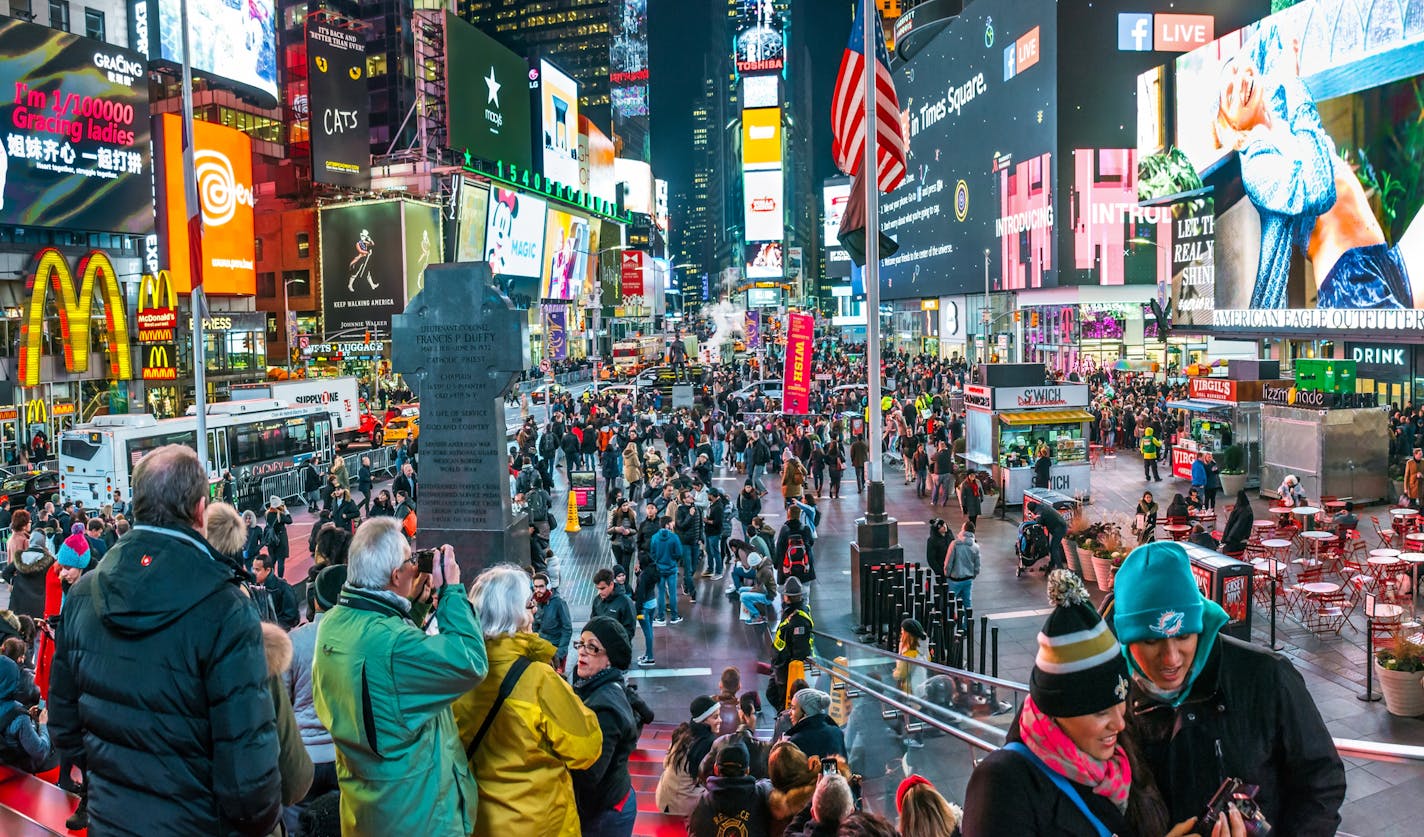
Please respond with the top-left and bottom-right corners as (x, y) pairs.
(454, 564), (604, 837)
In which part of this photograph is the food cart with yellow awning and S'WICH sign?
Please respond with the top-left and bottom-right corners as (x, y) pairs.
(964, 384), (1092, 505)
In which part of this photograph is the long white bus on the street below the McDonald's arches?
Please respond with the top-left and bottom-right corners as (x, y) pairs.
(58, 399), (335, 508)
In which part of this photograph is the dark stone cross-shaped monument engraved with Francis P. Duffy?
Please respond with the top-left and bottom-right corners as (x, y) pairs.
(392, 262), (530, 581)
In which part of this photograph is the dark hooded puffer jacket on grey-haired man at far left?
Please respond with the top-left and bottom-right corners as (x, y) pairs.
(50, 525), (282, 837)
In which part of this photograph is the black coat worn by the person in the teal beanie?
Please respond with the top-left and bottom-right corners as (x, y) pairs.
(1127, 636), (1344, 837)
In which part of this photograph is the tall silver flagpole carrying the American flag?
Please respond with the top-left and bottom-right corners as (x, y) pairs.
(860, 0), (884, 489)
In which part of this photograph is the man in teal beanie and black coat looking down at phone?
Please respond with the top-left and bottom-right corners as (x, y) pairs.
(1114, 541), (1344, 837)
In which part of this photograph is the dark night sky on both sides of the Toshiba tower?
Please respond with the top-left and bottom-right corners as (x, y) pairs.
(648, 0), (854, 219)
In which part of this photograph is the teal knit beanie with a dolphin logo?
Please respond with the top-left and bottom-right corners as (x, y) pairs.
(1112, 541), (1203, 645)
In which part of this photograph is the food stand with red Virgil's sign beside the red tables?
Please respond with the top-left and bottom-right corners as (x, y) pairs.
(1166, 377), (1276, 488)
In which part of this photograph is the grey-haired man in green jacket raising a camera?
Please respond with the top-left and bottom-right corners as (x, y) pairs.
(312, 517), (488, 837)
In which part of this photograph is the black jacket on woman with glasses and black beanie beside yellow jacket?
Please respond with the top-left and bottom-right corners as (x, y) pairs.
(570, 668), (638, 823)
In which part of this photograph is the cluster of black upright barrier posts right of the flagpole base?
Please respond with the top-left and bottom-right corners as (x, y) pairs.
(857, 562), (974, 668)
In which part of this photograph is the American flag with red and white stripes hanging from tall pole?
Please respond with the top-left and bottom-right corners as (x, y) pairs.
(830, 1), (906, 192)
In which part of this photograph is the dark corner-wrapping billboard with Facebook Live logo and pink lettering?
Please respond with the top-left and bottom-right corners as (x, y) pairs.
(880, 0), (1269, 299)
